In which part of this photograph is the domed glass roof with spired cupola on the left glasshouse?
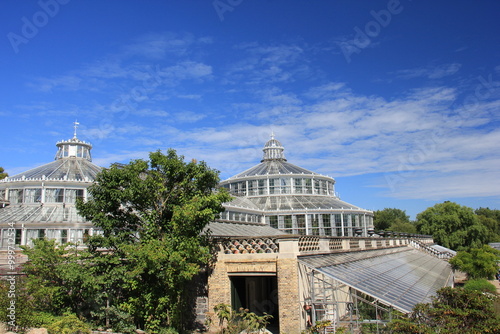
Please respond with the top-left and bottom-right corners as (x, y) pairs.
(4, 122), (101, 182)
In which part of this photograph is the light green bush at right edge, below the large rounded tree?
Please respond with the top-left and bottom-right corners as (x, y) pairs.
(449, 245), (500, 279)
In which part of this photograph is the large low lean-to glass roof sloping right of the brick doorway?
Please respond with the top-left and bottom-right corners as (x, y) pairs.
(299, 247), (453, 313)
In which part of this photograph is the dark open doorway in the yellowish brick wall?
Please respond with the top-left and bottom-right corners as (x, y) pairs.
(231, 276), (279, 327)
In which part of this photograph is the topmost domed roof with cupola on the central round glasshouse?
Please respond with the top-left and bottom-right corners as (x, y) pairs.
(229, 134), (320, 180)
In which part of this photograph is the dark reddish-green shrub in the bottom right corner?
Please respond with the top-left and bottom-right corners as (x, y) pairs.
(388, 287), (500, 334)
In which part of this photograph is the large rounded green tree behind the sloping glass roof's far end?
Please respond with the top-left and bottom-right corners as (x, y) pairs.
(416, 202), (489, 250)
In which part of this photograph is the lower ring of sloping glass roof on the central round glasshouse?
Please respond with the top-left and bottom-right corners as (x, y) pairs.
(248, 195), (364, 211)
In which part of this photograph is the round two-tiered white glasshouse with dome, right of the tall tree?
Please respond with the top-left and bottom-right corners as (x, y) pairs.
(220, 135), (373, 237)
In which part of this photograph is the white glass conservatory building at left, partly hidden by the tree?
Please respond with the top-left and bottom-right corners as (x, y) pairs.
(0, 131), (101, 248)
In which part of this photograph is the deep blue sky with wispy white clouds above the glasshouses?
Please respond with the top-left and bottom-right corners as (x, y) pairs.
(0, 0), (500, 218)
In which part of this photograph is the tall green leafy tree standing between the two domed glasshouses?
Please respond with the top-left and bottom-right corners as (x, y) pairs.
(77, 150), (230, 332)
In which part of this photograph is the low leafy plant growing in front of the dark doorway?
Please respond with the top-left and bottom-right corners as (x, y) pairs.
(214, 304), (273, 334)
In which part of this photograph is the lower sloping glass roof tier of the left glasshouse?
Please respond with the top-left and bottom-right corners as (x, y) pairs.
(0, 205), (87, 224)
